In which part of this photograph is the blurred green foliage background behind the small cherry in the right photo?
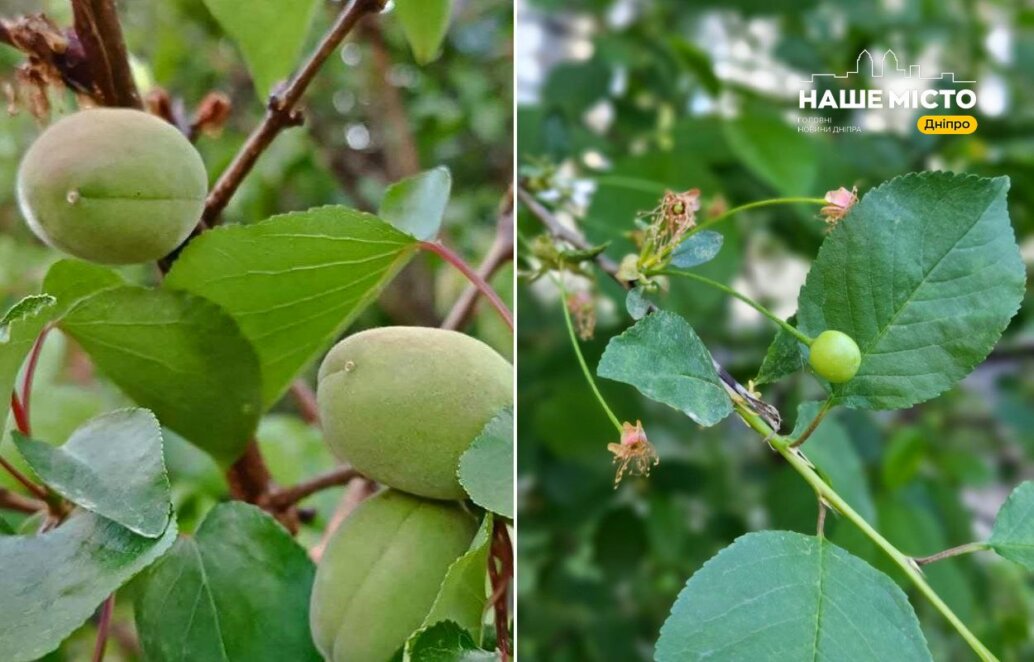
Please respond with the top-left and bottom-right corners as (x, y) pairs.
(517, 0), (1034, 662)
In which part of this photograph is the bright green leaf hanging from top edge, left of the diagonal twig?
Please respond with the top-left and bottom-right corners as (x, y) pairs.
(199, 0), (320, 101)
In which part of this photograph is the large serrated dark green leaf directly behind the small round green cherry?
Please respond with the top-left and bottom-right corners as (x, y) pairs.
(797, 173), (1025, 409)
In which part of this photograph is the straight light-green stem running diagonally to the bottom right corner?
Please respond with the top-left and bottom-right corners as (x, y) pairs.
(734, 402), (998, 662)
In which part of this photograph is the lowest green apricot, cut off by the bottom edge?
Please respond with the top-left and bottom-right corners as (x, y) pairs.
(309, 489), (478, 662)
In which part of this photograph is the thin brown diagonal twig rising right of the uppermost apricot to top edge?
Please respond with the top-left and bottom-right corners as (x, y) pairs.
(199, 0), (385, 230)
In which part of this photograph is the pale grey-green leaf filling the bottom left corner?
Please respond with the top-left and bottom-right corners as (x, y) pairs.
(0, 512), (176, 662)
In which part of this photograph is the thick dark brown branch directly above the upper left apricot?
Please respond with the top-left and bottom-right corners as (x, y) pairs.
(71, 0), (143, 109)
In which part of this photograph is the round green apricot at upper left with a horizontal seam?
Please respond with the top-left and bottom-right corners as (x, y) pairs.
(18, 108), (208, 265)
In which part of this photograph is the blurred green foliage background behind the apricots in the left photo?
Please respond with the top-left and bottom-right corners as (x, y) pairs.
(0, 0), (513, 660)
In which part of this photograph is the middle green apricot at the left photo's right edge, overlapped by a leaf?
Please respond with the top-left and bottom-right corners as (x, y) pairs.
(316, 327), (513, 499)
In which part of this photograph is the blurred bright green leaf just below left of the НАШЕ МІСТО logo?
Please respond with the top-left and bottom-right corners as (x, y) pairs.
(722, 108), (818, 195)
